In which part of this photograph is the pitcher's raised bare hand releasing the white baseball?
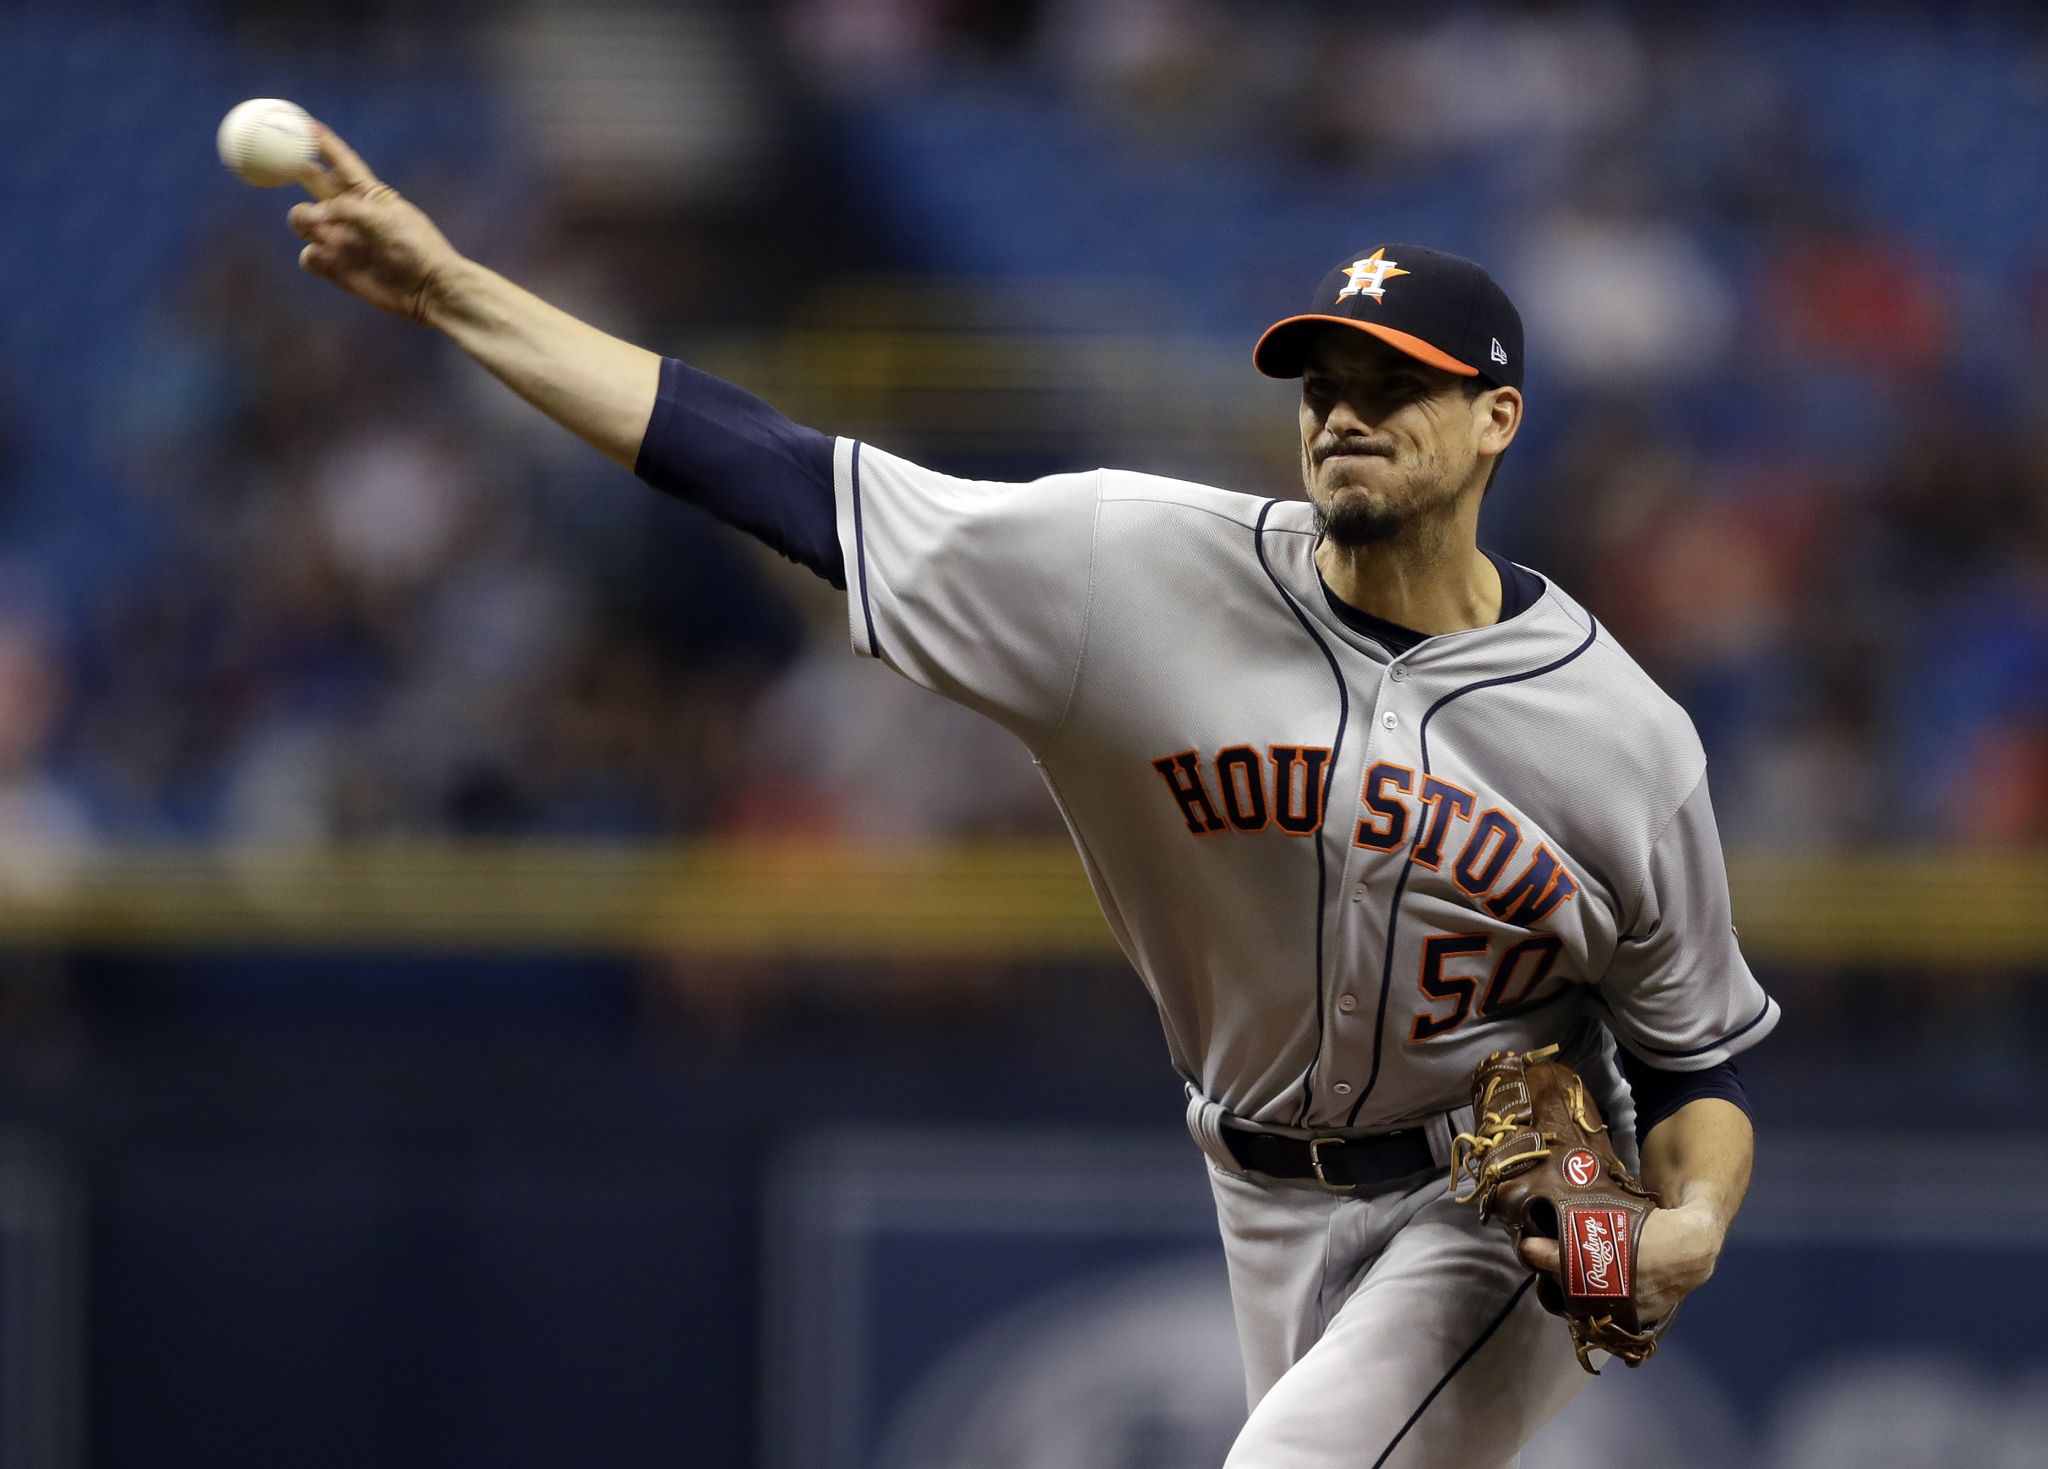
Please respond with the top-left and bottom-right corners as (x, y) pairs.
(289, 127), (465, 322)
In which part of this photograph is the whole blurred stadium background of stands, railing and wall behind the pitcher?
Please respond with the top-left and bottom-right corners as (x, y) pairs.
(0, 0), (2048, 1469)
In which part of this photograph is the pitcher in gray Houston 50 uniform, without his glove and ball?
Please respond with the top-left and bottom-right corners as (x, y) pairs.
(291, 133), (1778, 1469)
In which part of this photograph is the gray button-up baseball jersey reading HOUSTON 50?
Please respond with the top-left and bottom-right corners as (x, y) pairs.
(836, 438), (1778, 1129)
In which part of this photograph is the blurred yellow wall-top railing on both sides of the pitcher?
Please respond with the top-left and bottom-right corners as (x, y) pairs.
(0, 840), (2048, 969)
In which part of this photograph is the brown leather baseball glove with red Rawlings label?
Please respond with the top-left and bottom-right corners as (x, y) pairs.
(1450, 1045), (1671, 1375)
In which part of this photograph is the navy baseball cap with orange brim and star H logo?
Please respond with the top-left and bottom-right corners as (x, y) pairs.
(1251, 244), (1522, 387)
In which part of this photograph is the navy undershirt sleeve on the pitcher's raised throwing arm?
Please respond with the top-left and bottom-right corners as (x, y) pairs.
(633, 356), (846, 592)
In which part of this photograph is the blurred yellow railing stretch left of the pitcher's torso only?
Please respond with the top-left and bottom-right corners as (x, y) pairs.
(0, 842), (1114, 957)
